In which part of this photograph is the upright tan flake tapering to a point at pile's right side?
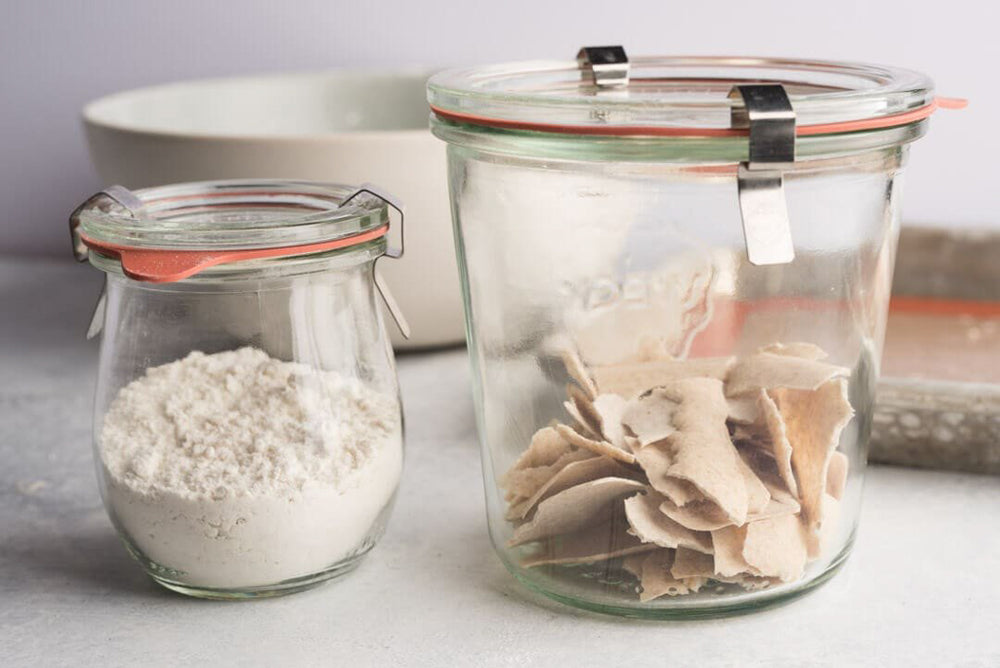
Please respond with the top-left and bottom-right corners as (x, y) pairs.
(773, 378), (854, 544)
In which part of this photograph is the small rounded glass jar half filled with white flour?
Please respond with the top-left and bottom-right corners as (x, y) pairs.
(73, 181), (403, 598)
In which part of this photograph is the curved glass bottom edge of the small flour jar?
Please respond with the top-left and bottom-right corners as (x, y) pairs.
(121, 537), (375, 601)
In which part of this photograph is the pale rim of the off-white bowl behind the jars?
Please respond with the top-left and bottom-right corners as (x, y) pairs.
(86, 65), (441, 143)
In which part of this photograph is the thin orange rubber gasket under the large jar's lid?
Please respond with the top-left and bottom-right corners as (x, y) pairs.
(431, 97), (968, 137)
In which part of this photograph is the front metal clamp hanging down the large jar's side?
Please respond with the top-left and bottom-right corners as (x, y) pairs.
(729, 84), (795, 265)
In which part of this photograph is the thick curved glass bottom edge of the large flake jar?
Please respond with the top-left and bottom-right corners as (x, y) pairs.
(502, 538), (853, 621)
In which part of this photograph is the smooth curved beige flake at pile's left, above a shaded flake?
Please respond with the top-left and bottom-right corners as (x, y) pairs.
(509, 478), (644, 546)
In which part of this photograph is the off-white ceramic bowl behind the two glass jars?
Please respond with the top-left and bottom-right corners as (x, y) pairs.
(83, 70), (464, 348)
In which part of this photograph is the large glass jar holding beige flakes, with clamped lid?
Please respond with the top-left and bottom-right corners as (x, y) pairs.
(429, 54), (952, 618)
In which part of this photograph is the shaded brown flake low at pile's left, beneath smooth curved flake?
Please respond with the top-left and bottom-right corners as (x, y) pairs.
(521, 518), (657, 568)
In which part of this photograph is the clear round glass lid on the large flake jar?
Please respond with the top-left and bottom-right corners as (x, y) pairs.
(428, 56), (934, 137)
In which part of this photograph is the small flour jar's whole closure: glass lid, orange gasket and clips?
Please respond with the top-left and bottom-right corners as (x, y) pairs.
(70, 180), (402, 283)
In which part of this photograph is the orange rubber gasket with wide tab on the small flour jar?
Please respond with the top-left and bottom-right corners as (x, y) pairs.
(80, 223), (389, 283)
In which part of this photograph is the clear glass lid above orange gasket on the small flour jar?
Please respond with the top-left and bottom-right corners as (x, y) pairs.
(79, 179), (389, 251)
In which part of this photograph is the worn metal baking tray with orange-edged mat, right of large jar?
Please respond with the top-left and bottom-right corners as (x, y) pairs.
(869, 228), (1000, 474)
